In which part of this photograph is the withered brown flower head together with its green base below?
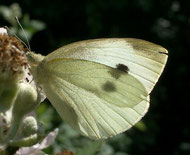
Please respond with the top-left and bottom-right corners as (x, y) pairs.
(0, 28), (28, 115)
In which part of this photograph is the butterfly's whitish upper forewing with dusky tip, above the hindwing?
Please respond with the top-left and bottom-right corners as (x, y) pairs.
(46, 38), (168, 93)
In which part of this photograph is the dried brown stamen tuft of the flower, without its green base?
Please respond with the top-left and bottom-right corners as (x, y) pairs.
(0, 28), (27, 81)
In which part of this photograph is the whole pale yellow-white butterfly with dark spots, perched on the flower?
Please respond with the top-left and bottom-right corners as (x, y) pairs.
(27, 38), (168, 139)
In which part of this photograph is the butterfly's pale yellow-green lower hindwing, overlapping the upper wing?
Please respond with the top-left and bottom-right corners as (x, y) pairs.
(36, 58), (149, 139)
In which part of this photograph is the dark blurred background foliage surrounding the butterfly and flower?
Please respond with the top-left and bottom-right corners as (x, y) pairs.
(0, 0), (190, 155)
